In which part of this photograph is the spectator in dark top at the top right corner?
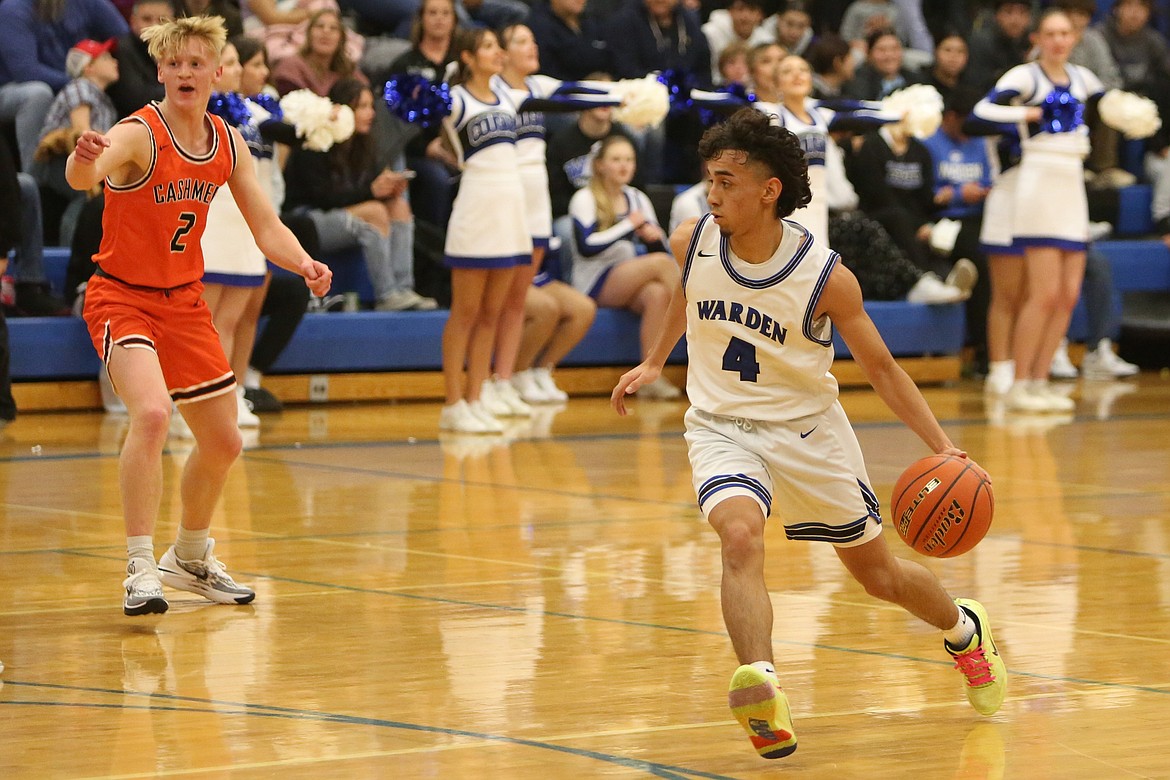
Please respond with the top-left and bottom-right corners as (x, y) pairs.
(1099, 0), (1170, 181)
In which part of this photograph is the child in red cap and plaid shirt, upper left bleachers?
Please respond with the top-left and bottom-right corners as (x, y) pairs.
(32, 40), (118, 244)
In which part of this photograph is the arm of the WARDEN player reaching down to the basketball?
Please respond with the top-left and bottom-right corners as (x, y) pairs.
(817, 262), (966, 457)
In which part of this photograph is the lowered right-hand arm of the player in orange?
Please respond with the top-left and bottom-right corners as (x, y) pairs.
(227, 127), (333, 296)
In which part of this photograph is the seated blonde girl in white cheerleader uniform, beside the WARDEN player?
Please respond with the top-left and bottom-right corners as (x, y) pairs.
(569, 136), (680, 399)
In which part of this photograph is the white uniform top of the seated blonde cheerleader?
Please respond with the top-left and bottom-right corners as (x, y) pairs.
(569, 185), (659, 298)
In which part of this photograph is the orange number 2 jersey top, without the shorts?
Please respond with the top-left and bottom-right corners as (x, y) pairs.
(94, 103), (235, 288)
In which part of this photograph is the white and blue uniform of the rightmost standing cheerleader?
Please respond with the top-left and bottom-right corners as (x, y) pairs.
(975, 62), (1104, 250)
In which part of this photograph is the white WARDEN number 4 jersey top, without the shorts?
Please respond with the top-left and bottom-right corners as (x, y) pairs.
(682, 214), (839, 421)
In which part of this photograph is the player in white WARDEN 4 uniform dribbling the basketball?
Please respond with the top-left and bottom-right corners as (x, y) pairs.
(612, 109), (1007, 758)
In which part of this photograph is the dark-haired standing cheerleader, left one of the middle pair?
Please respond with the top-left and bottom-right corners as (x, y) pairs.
(439, 29), (532, 434)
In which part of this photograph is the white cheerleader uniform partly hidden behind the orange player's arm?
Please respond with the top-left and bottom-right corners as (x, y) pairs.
(200, 98), (284, 287)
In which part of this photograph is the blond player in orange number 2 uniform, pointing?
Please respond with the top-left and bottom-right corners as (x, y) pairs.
(66, 16), (332, 615)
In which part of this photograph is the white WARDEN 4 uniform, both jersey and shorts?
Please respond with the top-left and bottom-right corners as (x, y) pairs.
(682, 210), (881, 546)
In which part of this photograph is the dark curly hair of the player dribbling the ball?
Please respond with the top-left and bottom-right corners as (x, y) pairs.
(698, 108), (812, 219)
